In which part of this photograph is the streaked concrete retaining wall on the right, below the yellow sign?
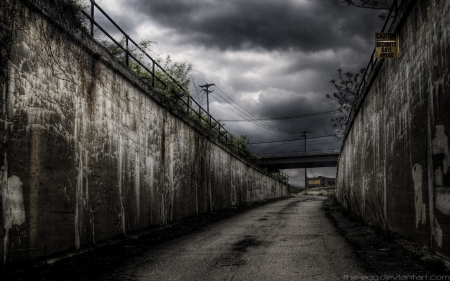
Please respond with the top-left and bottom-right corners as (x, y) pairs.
(337, 0), (450, 256)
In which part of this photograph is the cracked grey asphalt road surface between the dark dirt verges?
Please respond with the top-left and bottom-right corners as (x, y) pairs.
(108, 196), (369, 281)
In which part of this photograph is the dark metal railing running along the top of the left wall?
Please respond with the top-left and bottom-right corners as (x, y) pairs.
(81, 0), (289, 183)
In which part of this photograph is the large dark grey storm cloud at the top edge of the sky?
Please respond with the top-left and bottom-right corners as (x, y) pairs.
(129, 0), (380, 52)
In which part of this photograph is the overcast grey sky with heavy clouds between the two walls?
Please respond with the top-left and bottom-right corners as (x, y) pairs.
(89, 0), (383, 185)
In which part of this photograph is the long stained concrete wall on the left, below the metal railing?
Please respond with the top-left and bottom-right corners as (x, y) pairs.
(0, 1), (288, 263)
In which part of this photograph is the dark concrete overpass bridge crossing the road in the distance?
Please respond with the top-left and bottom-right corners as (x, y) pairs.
(261, 150), (339, 169)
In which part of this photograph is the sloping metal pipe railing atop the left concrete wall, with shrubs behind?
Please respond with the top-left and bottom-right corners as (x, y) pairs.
(77, 0), (289, 183)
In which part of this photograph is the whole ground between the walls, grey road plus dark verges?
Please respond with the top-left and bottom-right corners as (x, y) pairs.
(6, 196), (450, 281)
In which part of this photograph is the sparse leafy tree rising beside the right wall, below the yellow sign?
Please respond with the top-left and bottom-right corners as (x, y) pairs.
(326, 68), (365, 139)
